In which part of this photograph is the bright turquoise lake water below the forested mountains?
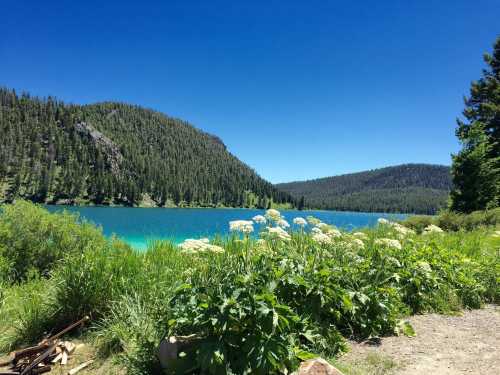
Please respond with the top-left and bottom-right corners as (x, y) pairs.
(46, 206), (406, 249)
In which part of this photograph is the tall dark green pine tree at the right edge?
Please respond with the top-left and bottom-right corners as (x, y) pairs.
(451, 37), (500, 212)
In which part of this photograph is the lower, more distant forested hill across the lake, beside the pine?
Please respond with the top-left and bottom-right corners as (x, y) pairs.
(276, 164), (451, 214)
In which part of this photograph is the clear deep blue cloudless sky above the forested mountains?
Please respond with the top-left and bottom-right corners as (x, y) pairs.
(0, 0), (500, 182)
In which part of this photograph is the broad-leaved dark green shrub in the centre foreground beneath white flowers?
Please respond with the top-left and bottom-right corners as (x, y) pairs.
(168, 256), (302, 375)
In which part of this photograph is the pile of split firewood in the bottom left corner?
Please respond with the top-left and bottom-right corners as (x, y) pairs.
(0, 316), (92, 375)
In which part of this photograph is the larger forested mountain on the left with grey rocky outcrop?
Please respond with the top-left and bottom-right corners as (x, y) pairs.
(0, 88), (293, 207)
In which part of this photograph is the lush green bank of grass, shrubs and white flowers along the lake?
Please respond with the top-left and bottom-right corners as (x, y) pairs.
(0, 202), (500, 374)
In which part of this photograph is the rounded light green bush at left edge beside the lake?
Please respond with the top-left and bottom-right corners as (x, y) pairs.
(0, 201), (107, 281)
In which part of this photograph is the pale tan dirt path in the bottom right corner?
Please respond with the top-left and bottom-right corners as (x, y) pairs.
(339, 305), (500, 375)
